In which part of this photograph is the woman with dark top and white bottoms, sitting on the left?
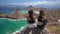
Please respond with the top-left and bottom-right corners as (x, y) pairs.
(27, 10), (35, 28)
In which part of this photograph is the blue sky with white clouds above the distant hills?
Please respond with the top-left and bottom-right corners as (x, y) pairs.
(0, 0), (60, 6)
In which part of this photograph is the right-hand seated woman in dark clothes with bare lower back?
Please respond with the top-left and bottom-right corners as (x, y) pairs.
(37, 10), (47, 28)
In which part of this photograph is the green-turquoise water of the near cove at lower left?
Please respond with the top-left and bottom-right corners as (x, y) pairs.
(0, 18), (27, 34)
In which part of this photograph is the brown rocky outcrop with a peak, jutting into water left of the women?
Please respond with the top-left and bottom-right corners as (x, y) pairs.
(0, 11), (23, 19)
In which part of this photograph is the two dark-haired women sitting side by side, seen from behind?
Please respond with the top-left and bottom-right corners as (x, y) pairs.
(27, 10), (47, 28)
